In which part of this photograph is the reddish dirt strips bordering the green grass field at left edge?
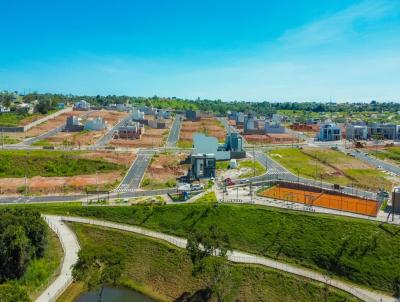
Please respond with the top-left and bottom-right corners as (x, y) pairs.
(0, 151), (136, 194)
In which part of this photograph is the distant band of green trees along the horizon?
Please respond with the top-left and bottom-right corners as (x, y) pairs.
(0, 93), (400, 115)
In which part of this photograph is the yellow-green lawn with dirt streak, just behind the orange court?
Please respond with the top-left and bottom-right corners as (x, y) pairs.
(268, 148), (392, 190)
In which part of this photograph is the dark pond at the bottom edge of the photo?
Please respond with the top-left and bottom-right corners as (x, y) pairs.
(76, 287), (155, 302)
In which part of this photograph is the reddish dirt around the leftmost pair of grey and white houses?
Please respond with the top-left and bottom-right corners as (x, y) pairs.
(40, 110), (127, 146)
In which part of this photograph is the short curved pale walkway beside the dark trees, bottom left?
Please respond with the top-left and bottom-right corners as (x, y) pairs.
(36, 215), (80, 302)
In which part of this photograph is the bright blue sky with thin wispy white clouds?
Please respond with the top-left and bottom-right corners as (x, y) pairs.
(0, 0), (400, 101)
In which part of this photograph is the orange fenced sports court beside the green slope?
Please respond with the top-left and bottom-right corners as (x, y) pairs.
(260, 185), (379, 216)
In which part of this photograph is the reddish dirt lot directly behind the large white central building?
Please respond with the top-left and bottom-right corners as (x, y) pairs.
(179, 118), (226, 144)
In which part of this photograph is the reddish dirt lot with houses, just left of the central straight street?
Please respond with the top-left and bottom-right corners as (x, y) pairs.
(110, 116), (172, 148)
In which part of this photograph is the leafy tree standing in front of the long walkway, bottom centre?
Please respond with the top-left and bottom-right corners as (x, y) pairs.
(186, 225), (240, 301)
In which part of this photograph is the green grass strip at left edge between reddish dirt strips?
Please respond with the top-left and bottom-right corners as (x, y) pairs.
(0, 150), (126, 177)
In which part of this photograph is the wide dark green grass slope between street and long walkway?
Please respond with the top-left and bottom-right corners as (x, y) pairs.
(12, 203), (400, 293)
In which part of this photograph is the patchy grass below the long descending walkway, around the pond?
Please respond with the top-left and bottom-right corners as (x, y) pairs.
(60, 224), (356, 302)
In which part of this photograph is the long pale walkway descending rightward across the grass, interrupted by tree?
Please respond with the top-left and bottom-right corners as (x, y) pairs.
(54, 216), (399, 302)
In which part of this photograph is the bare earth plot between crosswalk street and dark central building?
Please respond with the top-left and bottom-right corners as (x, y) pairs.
(141, 153), (187, 189)
